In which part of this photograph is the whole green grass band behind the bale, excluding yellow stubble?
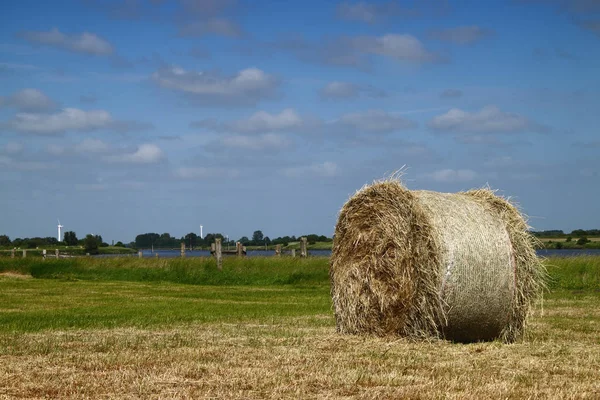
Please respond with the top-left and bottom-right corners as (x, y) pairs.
(0, 256), (600, 332)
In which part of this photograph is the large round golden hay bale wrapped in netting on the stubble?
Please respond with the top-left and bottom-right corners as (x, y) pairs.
(330, 179), (544, 342)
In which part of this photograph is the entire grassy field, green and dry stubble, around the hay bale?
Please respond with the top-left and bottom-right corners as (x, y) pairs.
(0, 257), (600, 399)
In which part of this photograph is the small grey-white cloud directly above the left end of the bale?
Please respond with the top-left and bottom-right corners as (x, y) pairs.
(334, 110), (416, 133)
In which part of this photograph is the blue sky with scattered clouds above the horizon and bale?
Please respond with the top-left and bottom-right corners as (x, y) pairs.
(0, 0), (600, 242)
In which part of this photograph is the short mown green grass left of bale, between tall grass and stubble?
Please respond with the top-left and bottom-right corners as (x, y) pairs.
(0, 277), (330, 332)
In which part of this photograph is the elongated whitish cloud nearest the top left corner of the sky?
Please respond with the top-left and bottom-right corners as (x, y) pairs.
(21, 28), (113, 56)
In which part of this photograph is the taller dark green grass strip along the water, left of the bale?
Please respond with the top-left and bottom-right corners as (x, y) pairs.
(0, 257), (329, 286)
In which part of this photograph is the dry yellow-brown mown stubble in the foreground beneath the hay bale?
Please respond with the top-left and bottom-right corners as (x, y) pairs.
(0, 296), (600, 399)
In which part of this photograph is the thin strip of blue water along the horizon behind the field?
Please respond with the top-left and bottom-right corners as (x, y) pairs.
(98, 249), (600, 258)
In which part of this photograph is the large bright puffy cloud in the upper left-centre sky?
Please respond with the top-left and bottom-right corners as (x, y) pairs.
(152, 67), (279, 103)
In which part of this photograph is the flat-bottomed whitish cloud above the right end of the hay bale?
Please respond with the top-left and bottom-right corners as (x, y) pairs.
(428, 106), (547, 134)
